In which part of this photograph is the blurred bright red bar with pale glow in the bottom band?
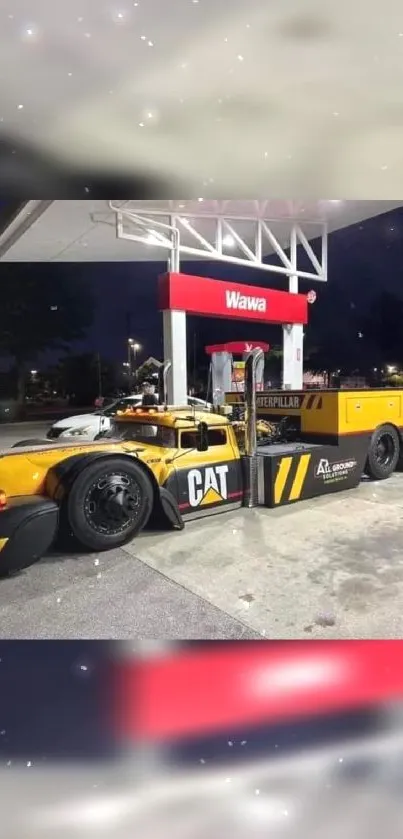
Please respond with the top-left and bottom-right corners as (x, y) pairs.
(113, 641), (403, 741)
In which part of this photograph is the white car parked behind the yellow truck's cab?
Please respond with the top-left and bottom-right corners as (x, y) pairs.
(46, 394), (211, 441)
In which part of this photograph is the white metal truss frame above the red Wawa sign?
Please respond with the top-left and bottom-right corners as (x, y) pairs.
(108, 201), (328, 284)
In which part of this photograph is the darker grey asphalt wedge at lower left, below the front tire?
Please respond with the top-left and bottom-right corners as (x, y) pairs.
(0, 550), (259, 639)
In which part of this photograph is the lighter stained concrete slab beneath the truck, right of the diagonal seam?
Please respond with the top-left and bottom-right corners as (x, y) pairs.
(126, 473), (403, 639)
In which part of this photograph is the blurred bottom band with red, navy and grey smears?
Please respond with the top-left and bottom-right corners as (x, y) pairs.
(0, 641), (403, 839)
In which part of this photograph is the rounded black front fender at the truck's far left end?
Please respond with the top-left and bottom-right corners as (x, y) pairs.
(0, 495), (59, 576)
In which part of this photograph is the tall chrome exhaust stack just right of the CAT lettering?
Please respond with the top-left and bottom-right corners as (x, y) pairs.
(243, 348), (264, 507)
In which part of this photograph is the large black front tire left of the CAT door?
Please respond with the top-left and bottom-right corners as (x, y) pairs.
(65, 456), (154, 551)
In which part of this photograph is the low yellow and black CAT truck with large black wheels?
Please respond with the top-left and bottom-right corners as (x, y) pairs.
(0, 350), (403, 575)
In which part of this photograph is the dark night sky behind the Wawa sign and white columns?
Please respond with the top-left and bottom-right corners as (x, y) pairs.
(0, 209), (403, 370)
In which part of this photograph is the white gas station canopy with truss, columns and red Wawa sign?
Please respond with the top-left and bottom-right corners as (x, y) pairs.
(0, 198), (402, 404)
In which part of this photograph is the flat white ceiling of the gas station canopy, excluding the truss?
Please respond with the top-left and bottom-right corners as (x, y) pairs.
(0, 200), (402, 262)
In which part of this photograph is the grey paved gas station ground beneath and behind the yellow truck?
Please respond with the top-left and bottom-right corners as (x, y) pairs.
(0, 424), (403, 639)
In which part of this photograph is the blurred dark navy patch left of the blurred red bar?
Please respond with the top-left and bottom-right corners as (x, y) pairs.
(0, 641), (114, 766)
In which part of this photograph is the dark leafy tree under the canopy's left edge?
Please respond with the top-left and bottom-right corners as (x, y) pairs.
(0, 263), (95, 406)
